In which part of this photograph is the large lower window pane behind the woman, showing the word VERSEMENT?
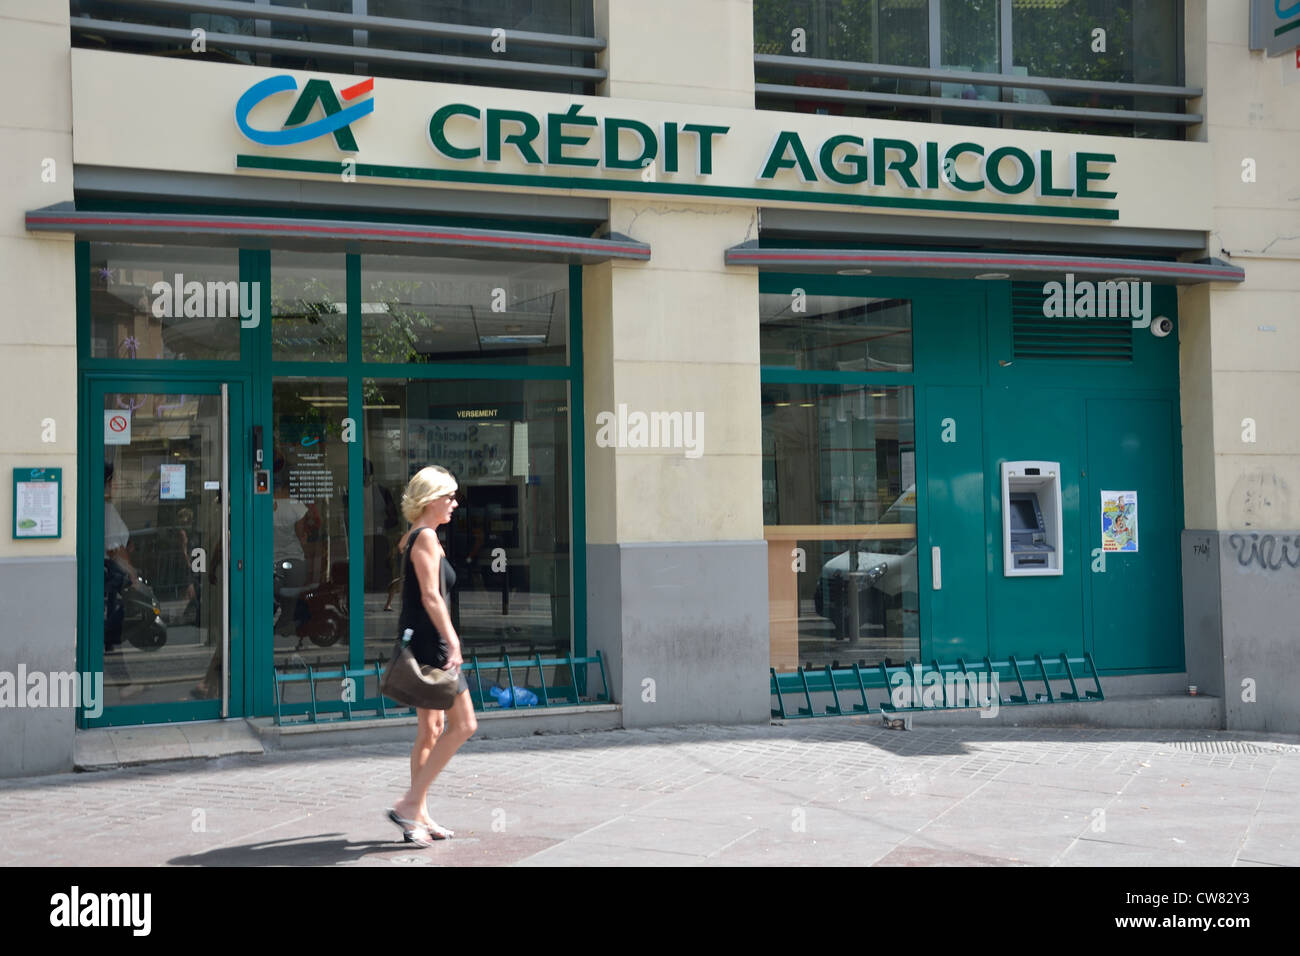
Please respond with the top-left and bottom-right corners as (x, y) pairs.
(363, 380), (572, 686)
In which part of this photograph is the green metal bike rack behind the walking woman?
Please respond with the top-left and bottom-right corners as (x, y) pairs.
(273, 650), (610, 726)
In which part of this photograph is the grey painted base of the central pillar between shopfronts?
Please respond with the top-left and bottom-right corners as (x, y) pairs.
(586, 541), (771, 727)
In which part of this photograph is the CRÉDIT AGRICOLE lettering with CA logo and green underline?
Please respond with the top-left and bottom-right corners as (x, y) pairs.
(235, 74), (1118, 220)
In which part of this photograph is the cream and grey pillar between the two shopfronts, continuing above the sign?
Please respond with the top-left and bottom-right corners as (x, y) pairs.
(582, 0), (768, 727)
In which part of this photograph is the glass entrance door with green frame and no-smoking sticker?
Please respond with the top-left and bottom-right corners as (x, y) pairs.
(82, 381), (243, 726)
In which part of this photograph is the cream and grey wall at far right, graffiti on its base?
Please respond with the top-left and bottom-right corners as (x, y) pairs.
(1179, 0), (1300, 732)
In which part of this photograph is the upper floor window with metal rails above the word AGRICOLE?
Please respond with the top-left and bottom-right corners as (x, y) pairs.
(754, 0), (1200, 139)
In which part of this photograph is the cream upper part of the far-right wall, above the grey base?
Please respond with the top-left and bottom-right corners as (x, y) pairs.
(1184, 3), (1300, 531)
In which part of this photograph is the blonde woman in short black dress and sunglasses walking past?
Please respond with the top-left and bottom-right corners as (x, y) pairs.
(389, 464), (478, 847)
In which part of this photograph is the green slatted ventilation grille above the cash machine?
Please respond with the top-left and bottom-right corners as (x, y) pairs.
(1011, 282), (1134, 362)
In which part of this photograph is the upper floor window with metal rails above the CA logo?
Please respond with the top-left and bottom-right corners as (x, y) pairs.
(70, 0), (605, 95)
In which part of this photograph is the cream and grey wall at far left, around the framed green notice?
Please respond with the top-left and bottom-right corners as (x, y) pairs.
(0, 0), (77, 775)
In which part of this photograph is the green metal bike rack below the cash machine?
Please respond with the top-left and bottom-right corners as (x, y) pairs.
(770, 653), (1105, 721)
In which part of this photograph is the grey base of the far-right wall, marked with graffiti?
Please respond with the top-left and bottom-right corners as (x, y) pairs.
(1182, 531), (1300, 734)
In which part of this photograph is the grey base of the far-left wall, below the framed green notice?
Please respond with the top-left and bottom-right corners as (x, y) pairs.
(0, 555), (77, 777)
